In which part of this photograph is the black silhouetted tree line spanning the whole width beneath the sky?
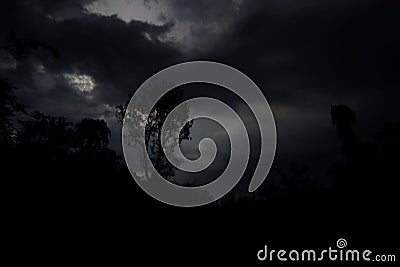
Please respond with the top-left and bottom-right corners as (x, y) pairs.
(0, 35), (400, 214)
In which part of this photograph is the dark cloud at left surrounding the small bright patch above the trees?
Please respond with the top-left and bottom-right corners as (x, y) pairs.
(0, 1), (181, 151)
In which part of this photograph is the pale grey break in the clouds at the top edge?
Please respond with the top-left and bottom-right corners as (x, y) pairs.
(84, 0), (245, 51)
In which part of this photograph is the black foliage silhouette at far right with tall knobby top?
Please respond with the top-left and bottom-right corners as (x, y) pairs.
(331, 105), (400, 206)
